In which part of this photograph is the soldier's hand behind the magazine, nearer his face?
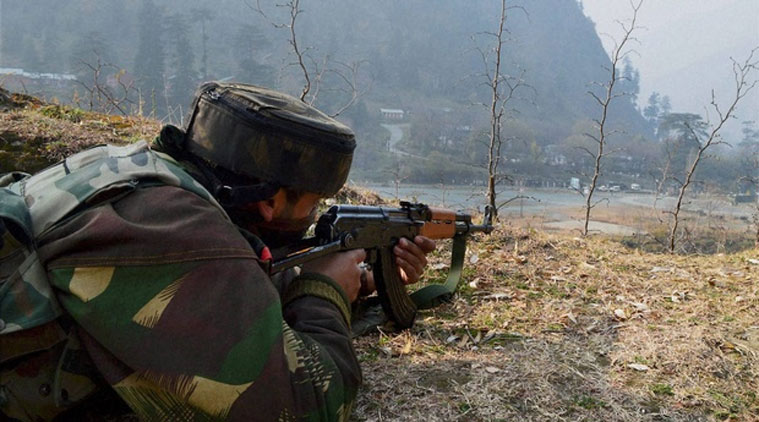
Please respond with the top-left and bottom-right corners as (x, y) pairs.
(303, 249), (366, 302)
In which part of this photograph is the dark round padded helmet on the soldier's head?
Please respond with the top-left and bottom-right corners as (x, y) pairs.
(184, 82), (356, 201)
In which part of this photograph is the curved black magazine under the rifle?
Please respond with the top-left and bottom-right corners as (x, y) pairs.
(372, 248), (416, 329)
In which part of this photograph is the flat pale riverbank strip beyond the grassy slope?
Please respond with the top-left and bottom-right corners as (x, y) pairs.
(362, 183), (757, 246)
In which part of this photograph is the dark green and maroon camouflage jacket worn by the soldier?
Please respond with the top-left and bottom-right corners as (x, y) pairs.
(1, 143), (361, 421)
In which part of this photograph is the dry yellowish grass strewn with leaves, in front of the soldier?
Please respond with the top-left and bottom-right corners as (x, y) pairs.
(354, 230), (759, 421)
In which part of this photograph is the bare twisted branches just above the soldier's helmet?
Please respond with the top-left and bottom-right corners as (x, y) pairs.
(244, 0), (371, 117)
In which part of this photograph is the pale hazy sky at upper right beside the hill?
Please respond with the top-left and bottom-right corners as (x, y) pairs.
(582, 0), (759, 135)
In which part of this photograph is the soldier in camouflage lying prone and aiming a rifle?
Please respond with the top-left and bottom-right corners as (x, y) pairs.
(0, 83), (435, 421)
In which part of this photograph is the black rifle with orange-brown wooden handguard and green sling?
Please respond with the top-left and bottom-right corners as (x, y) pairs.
(272, 202), (493, 328)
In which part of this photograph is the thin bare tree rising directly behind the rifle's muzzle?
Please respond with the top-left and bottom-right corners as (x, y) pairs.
(477, 0), (528, 220)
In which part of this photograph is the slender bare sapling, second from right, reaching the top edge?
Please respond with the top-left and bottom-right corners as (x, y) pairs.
(582, 0), (643, 236)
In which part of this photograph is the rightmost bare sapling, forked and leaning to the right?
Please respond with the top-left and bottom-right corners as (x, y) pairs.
(669, 47), (759, 253)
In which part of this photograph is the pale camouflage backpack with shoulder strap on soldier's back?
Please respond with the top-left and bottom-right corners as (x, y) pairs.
(0, 142), (223, 421)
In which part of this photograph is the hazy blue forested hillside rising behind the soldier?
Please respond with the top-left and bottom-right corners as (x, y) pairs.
(0, 0), (653, 180)
